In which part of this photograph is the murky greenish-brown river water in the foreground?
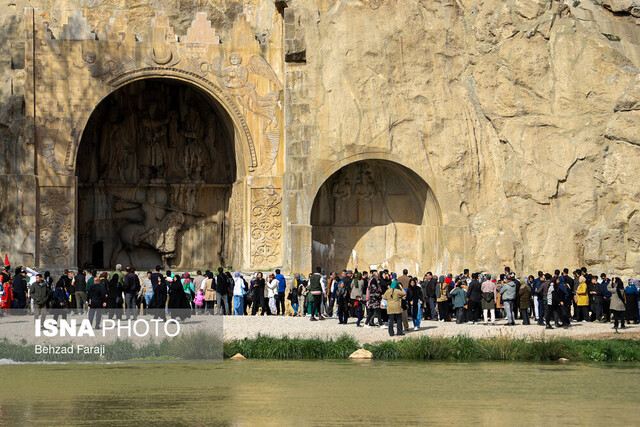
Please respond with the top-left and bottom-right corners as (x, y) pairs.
(0, 360), (640, 426)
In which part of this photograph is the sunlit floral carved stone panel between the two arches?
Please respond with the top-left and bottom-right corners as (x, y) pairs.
(251, 187), (282, 267)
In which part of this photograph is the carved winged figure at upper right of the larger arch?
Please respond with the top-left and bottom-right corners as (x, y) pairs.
(211, 52), (283, 129)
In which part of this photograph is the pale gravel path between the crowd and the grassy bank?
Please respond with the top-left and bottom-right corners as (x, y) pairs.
(0, 316), (640, 344)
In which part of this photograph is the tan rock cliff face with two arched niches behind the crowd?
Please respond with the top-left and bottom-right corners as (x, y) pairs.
(0, 0), (640, 274)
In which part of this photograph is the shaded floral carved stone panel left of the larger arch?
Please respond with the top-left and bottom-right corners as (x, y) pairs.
(38, 187), (73, 266)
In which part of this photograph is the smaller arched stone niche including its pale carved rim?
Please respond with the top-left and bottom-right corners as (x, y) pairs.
(309, 157), (443, 274)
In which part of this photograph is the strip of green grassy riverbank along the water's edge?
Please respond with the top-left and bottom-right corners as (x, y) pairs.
(0, 330), (640, 362)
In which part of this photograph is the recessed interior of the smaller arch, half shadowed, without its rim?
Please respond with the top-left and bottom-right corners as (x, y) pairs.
(311, 161), (437, 270)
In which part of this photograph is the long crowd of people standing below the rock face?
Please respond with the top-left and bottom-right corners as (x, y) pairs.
(0, 256), (640, 336)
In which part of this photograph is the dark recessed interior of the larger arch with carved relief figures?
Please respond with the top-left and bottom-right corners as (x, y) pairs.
(78, 81), (235, 267)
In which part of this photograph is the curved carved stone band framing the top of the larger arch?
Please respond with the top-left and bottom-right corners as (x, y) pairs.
(65, 67), (258, 175)
